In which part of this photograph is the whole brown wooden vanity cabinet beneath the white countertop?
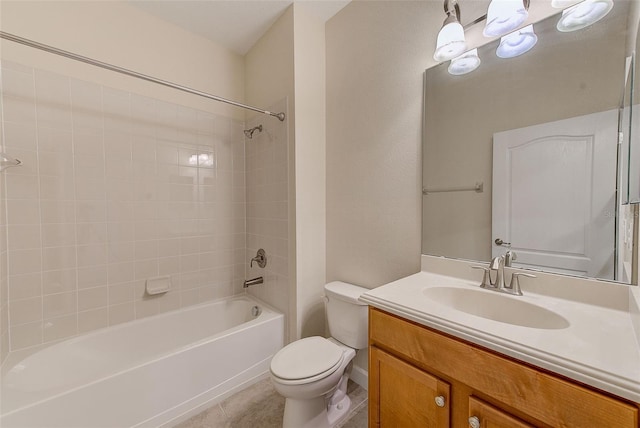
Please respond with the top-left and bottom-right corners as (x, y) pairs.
(369, 307), (639, 428)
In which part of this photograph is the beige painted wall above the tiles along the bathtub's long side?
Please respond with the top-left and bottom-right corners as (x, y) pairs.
(0, 0), (244, 120)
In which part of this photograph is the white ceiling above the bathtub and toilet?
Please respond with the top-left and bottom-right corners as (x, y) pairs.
(127, 0), (350, 55)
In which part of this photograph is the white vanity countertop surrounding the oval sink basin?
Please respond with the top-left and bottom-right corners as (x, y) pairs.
(360, 271), (640, 403)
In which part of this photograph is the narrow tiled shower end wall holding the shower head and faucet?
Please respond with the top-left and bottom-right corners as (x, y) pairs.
(246, 99), (290, 322)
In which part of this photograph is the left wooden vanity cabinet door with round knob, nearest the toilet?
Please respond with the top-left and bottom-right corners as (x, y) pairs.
(369, 346), (450, 428)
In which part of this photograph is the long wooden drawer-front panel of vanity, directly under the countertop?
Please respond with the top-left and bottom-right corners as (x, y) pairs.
(369, 308), (638, 428)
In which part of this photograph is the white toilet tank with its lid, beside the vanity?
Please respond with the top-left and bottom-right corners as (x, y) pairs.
(324, 281), (369, 349)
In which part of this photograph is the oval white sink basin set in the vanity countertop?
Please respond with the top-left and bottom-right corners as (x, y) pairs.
(423, 287), (569, 330)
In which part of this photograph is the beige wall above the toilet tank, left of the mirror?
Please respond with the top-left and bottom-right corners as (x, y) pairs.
(326, 1), (436, 288)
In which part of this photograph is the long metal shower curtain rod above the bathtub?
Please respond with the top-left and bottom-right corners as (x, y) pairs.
(0, 31), (285, 122)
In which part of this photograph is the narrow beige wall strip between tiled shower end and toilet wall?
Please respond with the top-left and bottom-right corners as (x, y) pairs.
(294, 2), (326, 337)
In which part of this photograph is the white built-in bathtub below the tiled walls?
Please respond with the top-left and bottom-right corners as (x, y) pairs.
(0, 296), (284, 428)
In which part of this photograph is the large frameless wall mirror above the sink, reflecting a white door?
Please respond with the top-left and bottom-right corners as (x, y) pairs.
(422, 1), (640, 282)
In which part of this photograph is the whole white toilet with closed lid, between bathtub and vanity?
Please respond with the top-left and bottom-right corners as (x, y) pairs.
(271, 281), (368, 428)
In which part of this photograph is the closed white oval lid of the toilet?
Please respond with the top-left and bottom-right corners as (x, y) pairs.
(271, 336), (343, 380)
